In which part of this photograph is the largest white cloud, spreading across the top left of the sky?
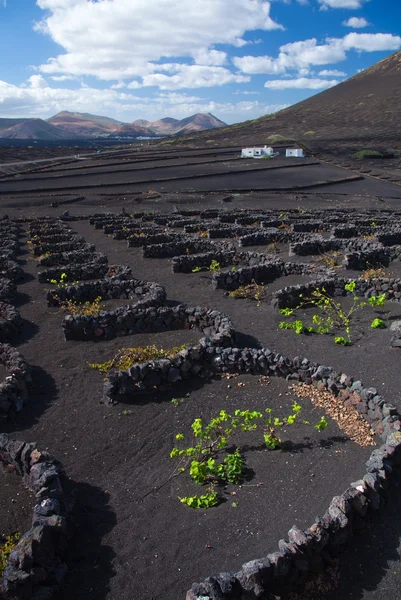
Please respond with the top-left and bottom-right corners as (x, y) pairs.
(36, 0), (282, 85)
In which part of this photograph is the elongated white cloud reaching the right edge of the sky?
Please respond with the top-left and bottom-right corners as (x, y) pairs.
(233, 33), (401, 75)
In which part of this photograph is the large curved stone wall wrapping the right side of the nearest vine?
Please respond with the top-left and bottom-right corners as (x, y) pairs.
(186, 348), (401, 600)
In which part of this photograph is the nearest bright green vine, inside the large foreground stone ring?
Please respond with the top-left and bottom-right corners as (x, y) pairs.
(170, 402), (328, 508)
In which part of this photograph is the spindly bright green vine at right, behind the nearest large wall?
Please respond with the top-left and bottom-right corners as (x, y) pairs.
(279, 281), (386, 346)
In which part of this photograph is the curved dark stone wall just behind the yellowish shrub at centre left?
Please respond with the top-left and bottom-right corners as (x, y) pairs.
(62, 304), (234, 346)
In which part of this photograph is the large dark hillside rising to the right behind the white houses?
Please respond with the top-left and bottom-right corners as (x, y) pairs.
(177, 51), (401, 153)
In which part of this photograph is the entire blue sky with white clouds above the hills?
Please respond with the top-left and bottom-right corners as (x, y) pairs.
(0, 0), (401, 124)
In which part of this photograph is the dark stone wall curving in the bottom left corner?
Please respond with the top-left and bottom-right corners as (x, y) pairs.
(0, 433), (72, 600)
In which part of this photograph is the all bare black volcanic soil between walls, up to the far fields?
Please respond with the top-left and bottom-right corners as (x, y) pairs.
(0, 135), (401, 600)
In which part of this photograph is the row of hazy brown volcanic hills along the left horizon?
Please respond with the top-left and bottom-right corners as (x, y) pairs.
(0, 110), (225, 140)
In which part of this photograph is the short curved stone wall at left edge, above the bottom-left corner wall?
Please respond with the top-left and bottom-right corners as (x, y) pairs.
(0, 344), (31, 423)
